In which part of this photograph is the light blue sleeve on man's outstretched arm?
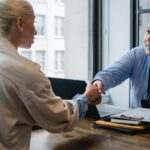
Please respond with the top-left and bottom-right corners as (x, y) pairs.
(93, 50), (134, 90)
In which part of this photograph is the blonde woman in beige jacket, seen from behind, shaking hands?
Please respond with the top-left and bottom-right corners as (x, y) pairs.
(0, 0), (99, 150)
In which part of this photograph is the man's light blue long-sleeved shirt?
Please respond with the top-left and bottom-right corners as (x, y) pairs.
(94, 46), (150, 107)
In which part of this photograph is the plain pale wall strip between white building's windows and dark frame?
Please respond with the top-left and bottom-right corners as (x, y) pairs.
(65, 0), (88, 80)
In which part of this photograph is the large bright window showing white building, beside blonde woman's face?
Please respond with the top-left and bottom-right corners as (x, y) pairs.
(20, 0), (89, 80)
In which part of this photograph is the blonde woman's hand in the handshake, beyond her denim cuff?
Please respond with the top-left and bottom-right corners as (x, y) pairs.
(83, 85), (101, 105)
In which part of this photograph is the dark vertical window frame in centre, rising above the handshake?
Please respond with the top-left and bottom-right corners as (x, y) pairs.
(88, 0), (102, 79)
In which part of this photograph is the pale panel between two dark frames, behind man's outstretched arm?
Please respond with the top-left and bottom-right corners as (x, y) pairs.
(103, 0), (130, 108)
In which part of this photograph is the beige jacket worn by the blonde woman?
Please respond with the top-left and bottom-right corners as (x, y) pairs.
(0, 38), (79, 150)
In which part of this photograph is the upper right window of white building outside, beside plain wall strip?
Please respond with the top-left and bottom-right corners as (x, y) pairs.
(54, 17), (64, 37)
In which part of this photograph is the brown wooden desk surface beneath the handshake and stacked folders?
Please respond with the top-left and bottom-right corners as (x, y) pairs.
(30, 120), (150, 150)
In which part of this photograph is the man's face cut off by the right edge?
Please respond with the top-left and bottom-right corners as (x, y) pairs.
(144, 24), (150, 55)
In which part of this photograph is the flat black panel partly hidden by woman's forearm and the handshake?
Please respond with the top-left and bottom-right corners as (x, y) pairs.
(48, 77), (99, 119)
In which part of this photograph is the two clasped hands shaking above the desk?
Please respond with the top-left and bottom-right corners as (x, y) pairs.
(83, 80), (105, 105)
